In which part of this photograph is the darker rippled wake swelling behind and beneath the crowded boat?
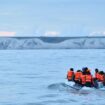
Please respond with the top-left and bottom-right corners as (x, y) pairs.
(48, 83), (105, 95)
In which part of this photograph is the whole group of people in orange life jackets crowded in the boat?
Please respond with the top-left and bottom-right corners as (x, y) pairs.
(67, 67), (105, 88)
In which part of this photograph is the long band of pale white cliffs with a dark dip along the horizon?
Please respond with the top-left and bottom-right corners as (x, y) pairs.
(0, 36), (105, 49)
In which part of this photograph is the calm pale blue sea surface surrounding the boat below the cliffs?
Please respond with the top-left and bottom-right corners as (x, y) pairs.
(0, 49), (105, 105)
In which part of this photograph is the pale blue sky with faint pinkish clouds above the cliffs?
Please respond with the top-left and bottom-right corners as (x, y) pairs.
(0, 0), (105, 37)
